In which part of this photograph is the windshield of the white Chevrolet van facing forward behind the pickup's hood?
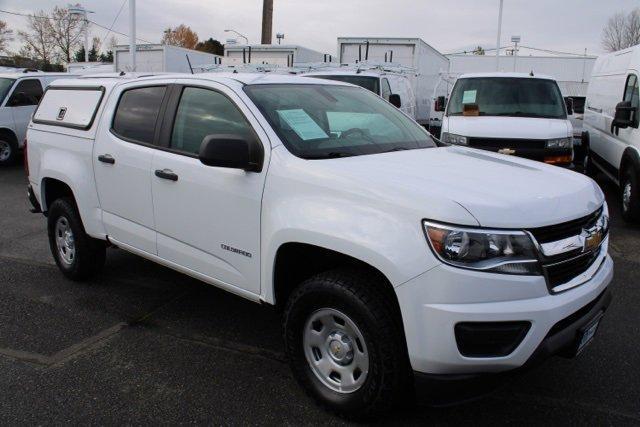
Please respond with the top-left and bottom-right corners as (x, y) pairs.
(447, 77), (567, 119)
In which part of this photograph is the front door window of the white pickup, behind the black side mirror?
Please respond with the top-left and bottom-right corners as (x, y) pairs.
(170, 87), (253, 155)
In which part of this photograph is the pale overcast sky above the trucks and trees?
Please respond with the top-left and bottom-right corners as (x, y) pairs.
(0, 0), (640, 54)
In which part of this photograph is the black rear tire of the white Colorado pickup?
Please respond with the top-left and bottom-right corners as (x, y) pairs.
(47, 197), (106, 281)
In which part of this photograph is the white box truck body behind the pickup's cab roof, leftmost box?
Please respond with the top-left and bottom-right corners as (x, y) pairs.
(114, 44), (222, 73)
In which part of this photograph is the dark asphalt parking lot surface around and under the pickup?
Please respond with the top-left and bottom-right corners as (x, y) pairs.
(0, 166), (640, 425)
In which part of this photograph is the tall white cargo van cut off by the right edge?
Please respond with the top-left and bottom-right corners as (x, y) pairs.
(584, 45), (640, 221)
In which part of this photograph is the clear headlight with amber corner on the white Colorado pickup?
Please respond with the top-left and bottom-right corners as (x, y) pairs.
(423, 221), (542, 275)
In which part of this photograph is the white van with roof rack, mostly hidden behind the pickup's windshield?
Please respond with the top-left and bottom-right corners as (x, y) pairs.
(302, 65), (417, 120)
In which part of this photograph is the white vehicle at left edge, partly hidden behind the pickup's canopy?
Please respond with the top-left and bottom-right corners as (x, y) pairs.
(0, 70), (75, 166)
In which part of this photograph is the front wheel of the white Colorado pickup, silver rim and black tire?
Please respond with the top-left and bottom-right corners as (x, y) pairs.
(284, 270), (411, 419)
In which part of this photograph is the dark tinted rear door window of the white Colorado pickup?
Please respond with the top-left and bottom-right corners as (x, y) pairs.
(112, 86), (167, 144)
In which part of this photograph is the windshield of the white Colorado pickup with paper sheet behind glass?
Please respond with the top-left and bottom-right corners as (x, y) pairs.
(244, 84), (435, 159)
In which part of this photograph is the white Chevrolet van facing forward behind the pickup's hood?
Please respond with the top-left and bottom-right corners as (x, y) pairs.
(441, 73), (573, 166)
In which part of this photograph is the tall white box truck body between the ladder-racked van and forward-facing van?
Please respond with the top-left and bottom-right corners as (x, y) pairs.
(338, 37), (449, 128)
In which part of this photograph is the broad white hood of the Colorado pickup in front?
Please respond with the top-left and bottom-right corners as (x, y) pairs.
(313, 147), (604, 228)
